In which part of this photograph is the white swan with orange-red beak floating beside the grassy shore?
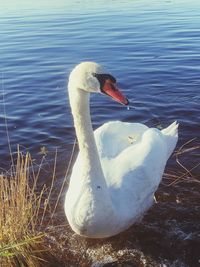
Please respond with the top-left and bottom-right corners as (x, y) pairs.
(65, 62), (178, 238)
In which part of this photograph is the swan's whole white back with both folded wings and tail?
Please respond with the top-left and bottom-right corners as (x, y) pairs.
(95, 121), (178, 224)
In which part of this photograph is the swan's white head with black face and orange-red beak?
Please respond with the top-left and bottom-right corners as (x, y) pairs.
(69, 62), (129, 105)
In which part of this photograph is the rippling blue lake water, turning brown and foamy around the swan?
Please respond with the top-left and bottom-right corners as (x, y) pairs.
(0, 0), (200, 267)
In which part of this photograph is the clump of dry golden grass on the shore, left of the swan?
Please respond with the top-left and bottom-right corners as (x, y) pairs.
(0, 151), (62, 267)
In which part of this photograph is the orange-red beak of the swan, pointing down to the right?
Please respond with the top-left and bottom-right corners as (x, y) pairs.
(102, 80), (129, 105)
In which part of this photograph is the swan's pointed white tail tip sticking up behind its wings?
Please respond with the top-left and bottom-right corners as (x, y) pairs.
(161, 121), (179, 158)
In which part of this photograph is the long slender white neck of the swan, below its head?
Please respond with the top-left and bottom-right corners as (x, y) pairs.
(69, 88), (105, 186)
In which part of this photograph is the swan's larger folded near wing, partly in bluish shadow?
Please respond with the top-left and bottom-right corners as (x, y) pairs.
(98, 128), (168, 222)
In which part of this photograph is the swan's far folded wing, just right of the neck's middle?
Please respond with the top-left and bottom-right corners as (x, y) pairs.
(94, 121), (148, 159)
